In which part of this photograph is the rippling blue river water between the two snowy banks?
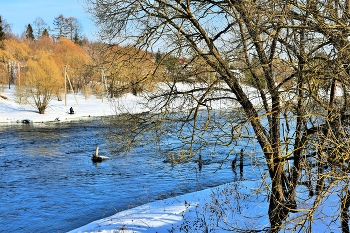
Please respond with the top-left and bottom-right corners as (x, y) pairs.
(0, 120), (258, 233)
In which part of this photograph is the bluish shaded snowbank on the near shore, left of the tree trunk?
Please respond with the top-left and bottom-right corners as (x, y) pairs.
(69, 181), (269, 233)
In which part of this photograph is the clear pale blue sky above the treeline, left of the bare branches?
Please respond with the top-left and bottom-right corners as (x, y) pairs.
(0, 0), (96, 39)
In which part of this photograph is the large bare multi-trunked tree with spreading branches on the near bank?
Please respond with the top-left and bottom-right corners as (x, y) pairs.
(88, 0), (349, 232)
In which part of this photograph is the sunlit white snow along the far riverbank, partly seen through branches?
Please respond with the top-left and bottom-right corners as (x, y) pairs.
(0, 83), (260, 123)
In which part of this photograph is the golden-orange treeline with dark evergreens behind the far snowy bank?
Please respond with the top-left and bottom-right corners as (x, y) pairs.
(0, 15), (235, 97)
